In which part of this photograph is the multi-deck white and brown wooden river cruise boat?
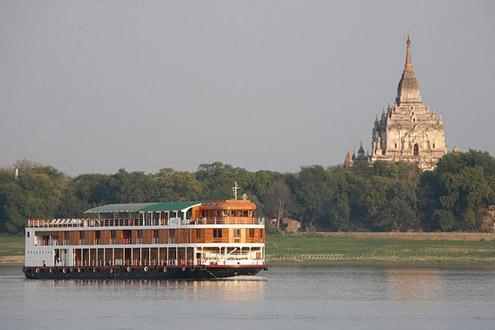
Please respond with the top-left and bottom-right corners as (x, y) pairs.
(24, 199), (266, 279)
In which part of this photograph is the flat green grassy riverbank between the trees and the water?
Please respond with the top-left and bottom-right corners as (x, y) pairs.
(0, 232), (495, 267)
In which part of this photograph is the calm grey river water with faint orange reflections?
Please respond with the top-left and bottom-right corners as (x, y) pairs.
(0, 266), (495, 330)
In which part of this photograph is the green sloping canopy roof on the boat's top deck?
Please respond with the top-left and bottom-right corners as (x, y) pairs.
(84, 201), (201, 214)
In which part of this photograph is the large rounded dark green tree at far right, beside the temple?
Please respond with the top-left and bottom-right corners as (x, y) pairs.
(418, 150), (495, 231)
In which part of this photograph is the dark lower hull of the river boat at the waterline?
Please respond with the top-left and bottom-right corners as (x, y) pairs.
(23, 266), (266, 280)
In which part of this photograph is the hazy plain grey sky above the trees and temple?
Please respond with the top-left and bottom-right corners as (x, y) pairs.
(0, 0), (495, 175)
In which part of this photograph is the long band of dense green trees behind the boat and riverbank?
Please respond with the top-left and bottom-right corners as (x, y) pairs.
(0, 150), (495, 234)
